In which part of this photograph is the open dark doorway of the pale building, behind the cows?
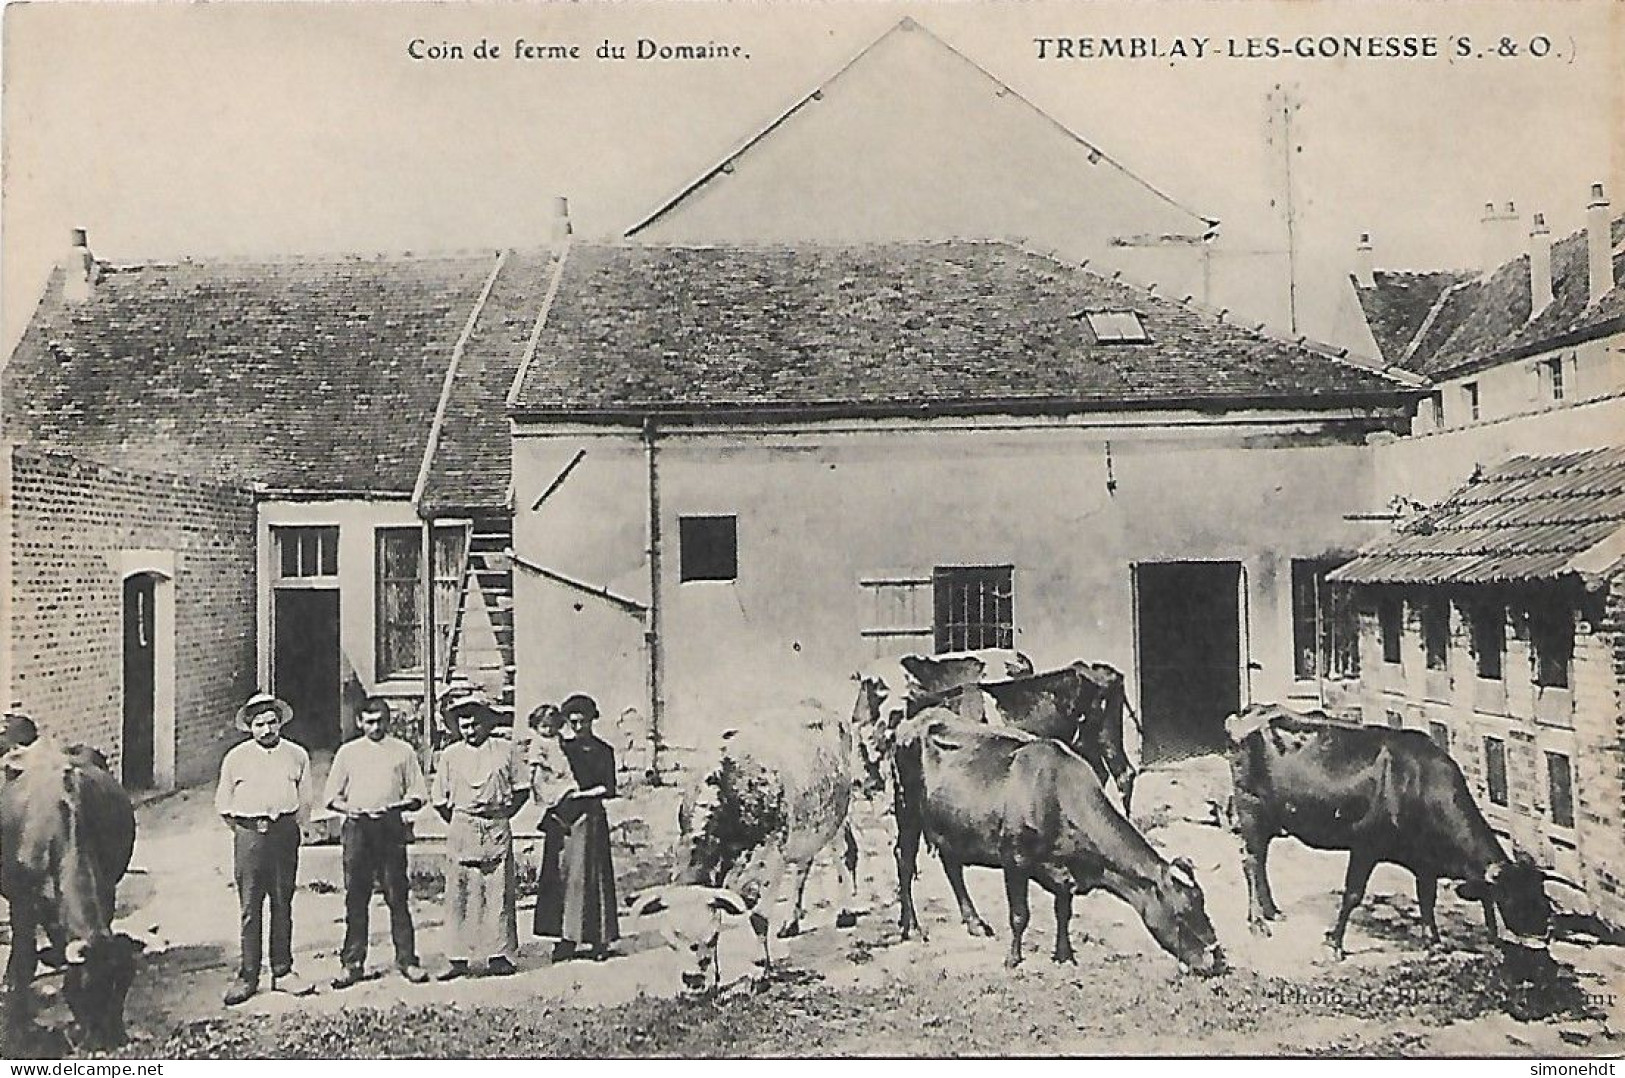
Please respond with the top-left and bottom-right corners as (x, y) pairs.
(1134, 561), (1242, 763)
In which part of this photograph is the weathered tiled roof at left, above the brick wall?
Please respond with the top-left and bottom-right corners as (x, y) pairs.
(3, 255), (496, 494)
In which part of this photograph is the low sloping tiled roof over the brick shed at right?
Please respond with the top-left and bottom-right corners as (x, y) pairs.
(1331, 447), (1625, 584)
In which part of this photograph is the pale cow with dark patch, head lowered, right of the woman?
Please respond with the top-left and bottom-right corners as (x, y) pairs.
(631, 693), (868, 989)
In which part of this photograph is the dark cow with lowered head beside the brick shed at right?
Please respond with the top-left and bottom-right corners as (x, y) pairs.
(1225, 704), (1552, 958)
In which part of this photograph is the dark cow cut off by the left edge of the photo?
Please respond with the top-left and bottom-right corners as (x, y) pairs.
(0, 741), (140, 1049)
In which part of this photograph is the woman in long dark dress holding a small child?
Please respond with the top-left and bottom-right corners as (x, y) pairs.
(535, 694), (621, 958)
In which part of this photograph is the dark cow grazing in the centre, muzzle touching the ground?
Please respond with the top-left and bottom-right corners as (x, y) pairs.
(874, 709), (1224, 974)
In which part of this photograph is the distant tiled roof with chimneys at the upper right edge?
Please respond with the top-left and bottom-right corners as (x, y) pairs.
(1359, 218), (1625, 379)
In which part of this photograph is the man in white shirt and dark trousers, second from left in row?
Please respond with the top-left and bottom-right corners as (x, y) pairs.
(322, 696), (429, 989)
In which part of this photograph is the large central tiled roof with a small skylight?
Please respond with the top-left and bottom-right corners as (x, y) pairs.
(514, 242), (1412, 418)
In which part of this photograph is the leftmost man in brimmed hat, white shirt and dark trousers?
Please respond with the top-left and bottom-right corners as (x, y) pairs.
(215, 693), (310, 1006)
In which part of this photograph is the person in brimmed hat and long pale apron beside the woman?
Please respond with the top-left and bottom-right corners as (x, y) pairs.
(434, 688), (530, 980)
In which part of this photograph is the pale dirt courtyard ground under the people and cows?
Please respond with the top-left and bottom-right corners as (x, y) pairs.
(3, 758), (1625, 1057)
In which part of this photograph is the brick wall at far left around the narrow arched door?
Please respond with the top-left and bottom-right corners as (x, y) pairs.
(7, 447), (255, 785)
